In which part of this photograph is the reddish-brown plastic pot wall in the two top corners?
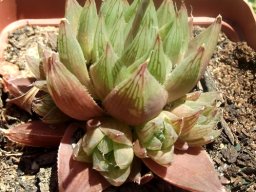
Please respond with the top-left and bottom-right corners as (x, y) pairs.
(0, 0), (256, 49)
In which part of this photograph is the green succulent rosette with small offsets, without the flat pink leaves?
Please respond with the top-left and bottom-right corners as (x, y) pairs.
(2, 0), (226, 191)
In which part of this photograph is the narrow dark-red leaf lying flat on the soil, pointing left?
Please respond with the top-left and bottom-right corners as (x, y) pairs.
(0, 121), (66, 147)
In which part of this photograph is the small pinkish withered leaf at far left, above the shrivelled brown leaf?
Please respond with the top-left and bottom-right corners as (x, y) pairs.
(3, 78), (35, 97)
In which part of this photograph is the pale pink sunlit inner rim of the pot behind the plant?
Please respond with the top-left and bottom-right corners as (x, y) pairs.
(0, 17), (240, 61)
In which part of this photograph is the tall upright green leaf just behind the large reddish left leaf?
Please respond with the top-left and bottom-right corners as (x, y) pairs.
(58, 20), (91, 89)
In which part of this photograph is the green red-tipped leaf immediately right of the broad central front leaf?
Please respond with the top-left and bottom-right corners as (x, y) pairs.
(165, 47), (205, 102)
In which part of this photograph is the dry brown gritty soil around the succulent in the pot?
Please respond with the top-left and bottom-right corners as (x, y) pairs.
(0, 26), (256, 192)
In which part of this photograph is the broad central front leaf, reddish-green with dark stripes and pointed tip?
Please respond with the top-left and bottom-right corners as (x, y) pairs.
(103, 63), (167, 125)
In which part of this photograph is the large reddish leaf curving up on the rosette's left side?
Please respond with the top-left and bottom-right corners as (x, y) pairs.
(44, 51), (102, 120)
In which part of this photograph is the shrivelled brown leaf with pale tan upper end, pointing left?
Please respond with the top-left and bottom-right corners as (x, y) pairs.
(8, 87), (39, 114)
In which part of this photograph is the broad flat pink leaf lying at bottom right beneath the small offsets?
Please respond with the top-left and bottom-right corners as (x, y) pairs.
(143, 148), (225, 192)
